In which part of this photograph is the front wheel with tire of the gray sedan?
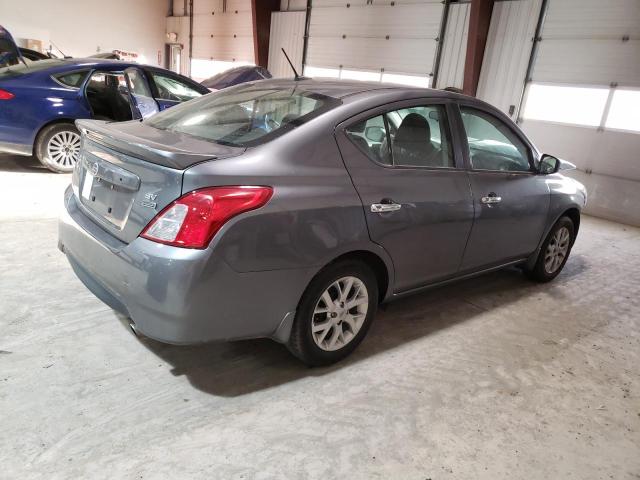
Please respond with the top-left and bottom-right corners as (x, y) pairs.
(525, 217), (575, 282)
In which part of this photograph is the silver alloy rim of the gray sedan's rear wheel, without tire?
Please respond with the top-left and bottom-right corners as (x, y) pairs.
(311, 277), (369, 351)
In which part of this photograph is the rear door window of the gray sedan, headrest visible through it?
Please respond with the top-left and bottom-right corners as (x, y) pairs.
(346, 105), (454, 168)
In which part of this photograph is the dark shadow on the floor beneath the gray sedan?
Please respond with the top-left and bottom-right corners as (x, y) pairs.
(139, 259), (588, 397)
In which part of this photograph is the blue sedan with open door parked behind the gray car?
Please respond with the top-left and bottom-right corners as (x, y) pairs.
(0, 59), (209, 172)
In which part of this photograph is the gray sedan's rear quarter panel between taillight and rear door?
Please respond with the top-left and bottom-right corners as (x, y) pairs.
(183, 111), (393, 282)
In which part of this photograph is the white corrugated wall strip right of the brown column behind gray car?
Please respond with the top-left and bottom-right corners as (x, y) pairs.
(477, 0), (542, 120)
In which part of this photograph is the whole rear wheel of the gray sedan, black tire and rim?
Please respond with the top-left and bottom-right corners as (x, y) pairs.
(287, 261), (378, 366)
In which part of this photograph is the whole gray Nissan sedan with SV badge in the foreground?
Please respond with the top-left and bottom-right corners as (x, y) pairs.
(59, 79), (586, 365)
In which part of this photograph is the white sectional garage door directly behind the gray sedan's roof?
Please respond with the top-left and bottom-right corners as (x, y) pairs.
(305, 0), (443, 84)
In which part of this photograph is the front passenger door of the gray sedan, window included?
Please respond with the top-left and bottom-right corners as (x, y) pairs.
(460, 106), (550, 272)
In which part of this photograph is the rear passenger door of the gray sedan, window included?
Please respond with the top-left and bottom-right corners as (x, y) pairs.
(336, 100), (473, 293)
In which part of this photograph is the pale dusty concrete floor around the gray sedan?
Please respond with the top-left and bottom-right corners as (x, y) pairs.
(0, 157), (640, 480)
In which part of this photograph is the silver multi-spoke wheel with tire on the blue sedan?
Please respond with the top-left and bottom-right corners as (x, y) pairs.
(35, 123), (80, 173)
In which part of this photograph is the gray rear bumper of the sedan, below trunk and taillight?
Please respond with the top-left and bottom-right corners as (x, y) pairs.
(59, 188), (313, 344)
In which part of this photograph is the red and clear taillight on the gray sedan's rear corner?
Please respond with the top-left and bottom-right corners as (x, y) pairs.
(140, 187), (273, 248)
